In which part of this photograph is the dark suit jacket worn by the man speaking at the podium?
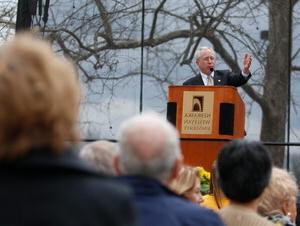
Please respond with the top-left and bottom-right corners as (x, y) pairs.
(183, 70), (251, 87)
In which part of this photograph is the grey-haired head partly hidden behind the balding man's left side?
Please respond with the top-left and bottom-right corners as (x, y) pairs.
(79, 140), (118, 176)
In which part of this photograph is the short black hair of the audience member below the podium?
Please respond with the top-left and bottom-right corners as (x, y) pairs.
(217, 140), (272, 203)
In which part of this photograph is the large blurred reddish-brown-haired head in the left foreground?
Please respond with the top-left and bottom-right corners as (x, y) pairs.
(0, 34), (80, 158)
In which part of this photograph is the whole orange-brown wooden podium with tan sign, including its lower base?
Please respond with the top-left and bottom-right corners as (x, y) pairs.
(167, 85), (245, 171)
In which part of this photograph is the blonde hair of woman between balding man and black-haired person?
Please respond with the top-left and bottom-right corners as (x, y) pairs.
(169, 166), (198, 195)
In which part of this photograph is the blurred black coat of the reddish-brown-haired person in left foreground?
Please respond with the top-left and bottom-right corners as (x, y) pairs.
(0, 147), (136, 226)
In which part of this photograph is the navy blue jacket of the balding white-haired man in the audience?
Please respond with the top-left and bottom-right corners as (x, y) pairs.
(121, 176), (224, 226)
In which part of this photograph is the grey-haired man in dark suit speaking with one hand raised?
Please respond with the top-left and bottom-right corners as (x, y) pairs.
(183, 47), (252, 87)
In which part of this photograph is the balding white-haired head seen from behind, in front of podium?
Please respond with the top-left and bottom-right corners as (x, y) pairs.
(117, 113), (182, 184)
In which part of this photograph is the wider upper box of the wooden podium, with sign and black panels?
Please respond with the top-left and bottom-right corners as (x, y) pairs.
(167, 86), (245, 140)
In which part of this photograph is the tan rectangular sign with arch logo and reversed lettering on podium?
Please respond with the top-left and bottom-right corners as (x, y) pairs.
(181, 91), (214, 134)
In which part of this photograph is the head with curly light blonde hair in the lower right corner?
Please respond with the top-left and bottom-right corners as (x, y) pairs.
(258, 167), (298, 222)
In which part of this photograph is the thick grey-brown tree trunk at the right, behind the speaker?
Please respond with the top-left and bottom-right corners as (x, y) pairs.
(260, 0), (290, 166)
